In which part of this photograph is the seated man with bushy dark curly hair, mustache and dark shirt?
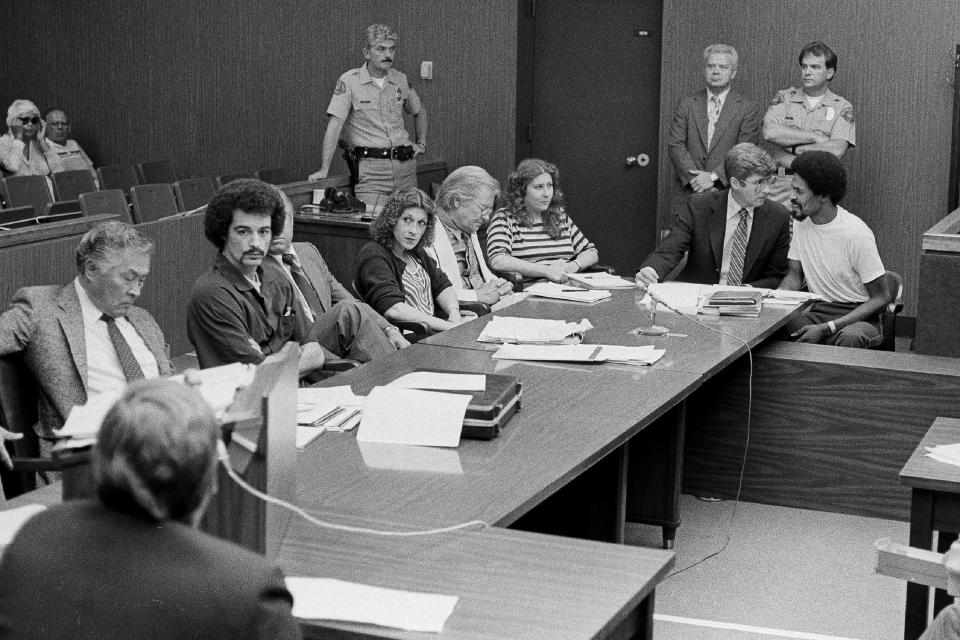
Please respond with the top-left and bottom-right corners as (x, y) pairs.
(187, 179), (326, 375)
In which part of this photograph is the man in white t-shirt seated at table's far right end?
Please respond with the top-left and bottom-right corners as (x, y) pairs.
(780, 151), (890, 348)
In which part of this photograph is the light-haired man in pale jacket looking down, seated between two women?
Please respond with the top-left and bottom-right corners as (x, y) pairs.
(428, 166), (513, 305)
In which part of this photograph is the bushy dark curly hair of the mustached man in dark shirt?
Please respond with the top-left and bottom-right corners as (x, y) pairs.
(203, 178), (285, 251)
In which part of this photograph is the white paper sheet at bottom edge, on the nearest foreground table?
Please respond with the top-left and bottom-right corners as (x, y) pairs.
(287, 577), (459, 633)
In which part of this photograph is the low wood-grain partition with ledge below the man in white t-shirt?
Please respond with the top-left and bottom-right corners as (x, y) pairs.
(683, 341), (960, 520)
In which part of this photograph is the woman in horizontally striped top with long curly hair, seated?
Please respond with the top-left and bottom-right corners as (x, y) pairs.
(487, 158), (599, 283)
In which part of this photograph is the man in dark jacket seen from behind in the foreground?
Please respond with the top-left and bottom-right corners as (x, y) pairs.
(0, 380), (300, 640)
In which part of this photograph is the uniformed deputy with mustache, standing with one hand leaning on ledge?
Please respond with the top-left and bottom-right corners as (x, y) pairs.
(310, 24), (427, 207)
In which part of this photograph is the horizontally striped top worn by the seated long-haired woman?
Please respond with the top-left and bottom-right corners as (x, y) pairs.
(487, 209), (596, 262)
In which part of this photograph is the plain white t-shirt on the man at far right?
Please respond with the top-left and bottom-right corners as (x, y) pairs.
(787, 207), (884, 304)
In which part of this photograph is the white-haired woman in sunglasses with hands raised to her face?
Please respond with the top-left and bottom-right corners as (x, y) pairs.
(0, 100), (59, 176)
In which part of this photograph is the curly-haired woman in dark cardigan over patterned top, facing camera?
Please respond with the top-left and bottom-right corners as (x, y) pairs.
(356, 189), (463, 331)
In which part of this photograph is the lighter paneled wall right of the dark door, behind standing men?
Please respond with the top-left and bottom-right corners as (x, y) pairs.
(659, 0), (960, 315)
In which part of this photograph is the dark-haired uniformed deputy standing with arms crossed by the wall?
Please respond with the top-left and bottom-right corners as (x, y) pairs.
(763, 42), (857, 208)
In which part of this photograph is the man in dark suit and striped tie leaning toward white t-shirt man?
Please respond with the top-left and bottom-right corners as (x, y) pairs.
(637, 142), (790, 288)
